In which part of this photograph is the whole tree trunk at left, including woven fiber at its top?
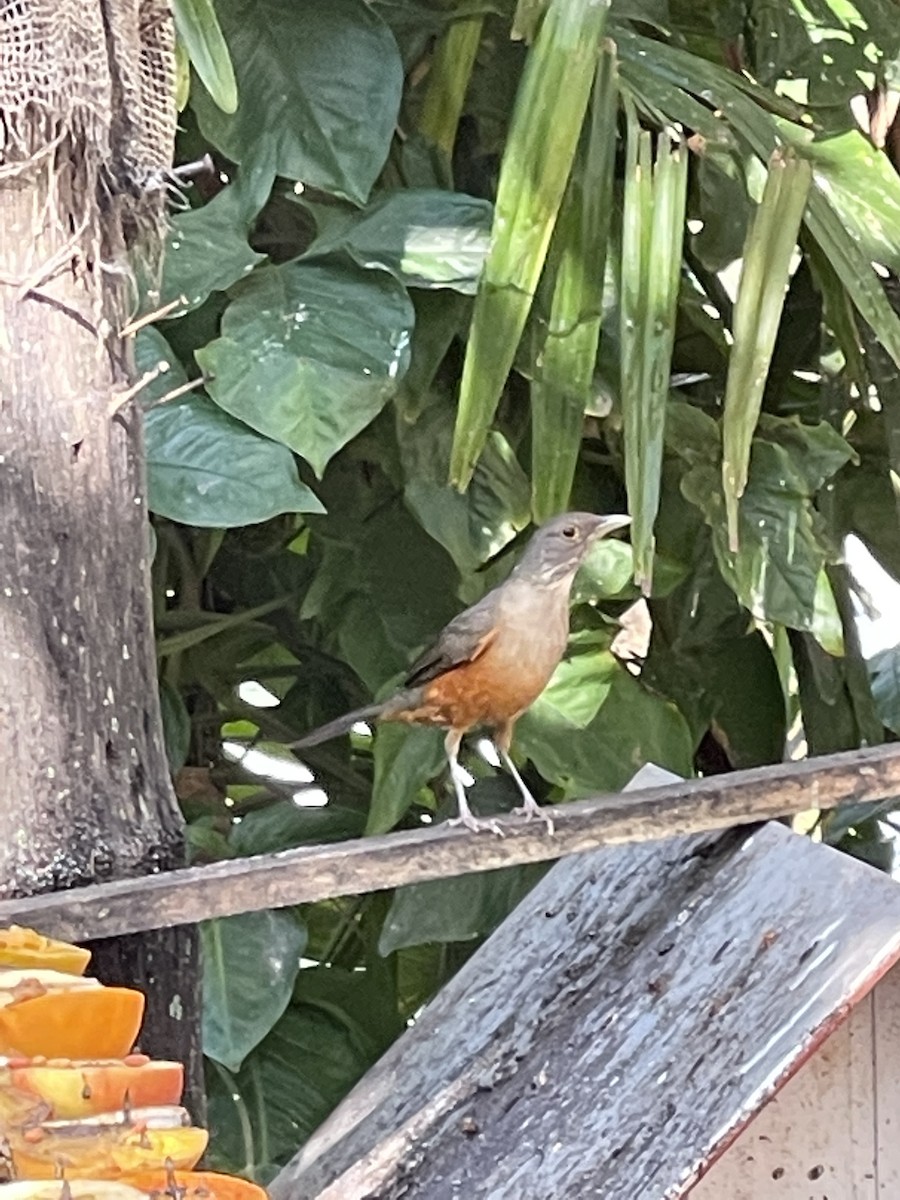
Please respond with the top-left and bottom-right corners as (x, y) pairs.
(0, 0), (198, 1104)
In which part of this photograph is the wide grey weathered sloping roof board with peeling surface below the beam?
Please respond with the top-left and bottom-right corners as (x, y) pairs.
(271, 792), (900, 1200)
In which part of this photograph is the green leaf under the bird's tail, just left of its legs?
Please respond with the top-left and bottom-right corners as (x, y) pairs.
(366, 725), (446, 834)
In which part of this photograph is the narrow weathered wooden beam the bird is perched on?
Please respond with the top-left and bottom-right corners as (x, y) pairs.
(0, 745), (900, 941)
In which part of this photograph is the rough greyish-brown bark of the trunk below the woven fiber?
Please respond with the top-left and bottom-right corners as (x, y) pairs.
(0, 114), (198, 1099)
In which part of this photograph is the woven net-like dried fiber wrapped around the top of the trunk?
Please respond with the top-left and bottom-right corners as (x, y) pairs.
(0, 0), (175, 258)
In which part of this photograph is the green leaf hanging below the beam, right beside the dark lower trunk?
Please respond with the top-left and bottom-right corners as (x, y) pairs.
(200, 910), (306, 1070)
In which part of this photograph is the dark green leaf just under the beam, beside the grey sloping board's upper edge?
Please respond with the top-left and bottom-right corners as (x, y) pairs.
(378, 863), (547, 955)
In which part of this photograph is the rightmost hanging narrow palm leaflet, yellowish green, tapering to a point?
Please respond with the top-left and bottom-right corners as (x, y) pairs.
(722, 151), (812, 551)
